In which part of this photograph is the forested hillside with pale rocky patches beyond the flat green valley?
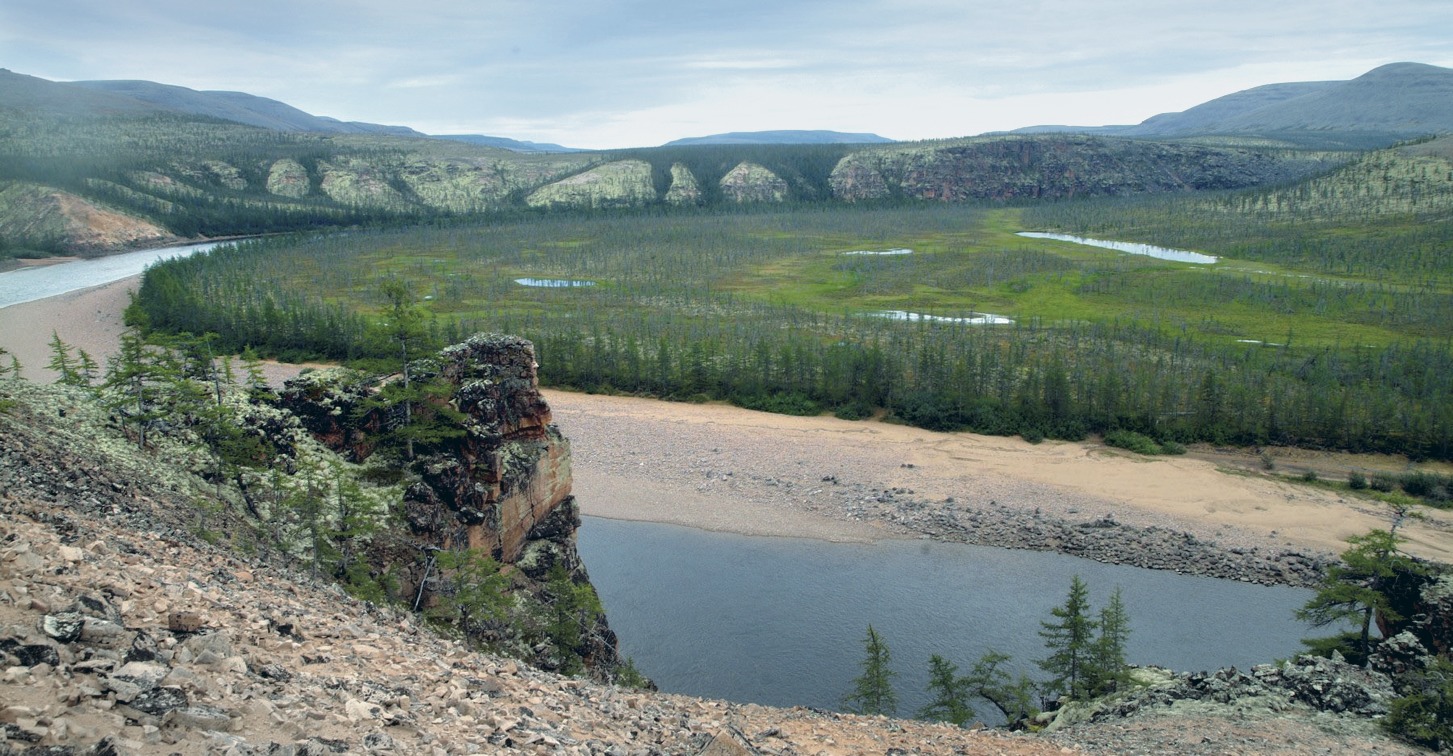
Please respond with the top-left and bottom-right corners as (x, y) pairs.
(0, 71), (1351, 256)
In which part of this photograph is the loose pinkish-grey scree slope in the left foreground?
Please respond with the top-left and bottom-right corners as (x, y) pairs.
(0, 372), (1061, 755)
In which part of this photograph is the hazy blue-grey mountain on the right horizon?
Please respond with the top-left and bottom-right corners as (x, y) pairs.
(1013, 63), (1453, 138)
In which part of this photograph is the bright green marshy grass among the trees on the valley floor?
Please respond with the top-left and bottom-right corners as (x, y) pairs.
(721, 209), (1429, 346)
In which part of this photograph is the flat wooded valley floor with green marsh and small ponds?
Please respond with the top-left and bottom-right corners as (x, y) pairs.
(127, 131), (1453, 459)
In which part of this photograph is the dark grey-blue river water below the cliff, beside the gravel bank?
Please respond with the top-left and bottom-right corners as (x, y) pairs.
(580, 518), (1311, 715)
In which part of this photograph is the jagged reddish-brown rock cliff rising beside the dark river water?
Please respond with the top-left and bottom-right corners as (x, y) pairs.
(279, 334), (620, 680)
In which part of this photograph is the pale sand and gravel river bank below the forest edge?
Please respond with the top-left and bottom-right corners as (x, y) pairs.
(0, 278), (1453, 561)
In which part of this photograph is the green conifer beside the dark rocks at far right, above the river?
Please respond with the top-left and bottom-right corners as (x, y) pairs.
(1296, 529), (1427, 664)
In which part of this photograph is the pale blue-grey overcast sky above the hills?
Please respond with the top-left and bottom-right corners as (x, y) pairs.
(0, 0), (1453, 148)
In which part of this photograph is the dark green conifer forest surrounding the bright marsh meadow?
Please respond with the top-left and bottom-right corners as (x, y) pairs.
(137, 211), (1453, 459)
